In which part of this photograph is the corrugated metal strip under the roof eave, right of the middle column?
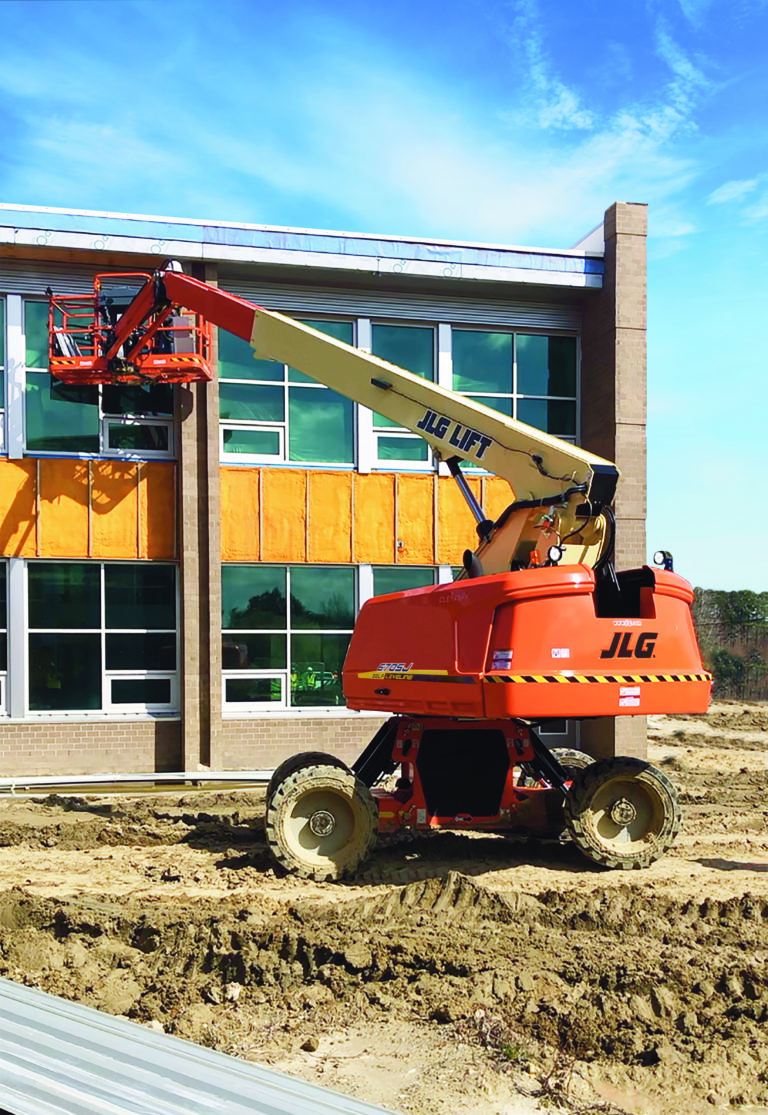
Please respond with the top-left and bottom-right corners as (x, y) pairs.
(222, 280), (582, 332)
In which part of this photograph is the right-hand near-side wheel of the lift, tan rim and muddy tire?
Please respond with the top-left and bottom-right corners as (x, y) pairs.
(564, 757), (681, 871)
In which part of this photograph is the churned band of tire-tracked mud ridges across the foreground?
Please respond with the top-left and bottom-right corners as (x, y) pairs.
(0, 872), (768, 1103)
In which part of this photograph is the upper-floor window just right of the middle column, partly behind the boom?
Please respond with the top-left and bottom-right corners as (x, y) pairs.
(218, 321), (354, 464)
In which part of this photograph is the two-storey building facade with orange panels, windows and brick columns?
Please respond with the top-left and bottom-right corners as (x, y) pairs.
(0, 203), (647, 776)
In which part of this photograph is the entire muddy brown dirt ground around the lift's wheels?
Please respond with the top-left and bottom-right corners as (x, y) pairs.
(0, 704), (768, 1115)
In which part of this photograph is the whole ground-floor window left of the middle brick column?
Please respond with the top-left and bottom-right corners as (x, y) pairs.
(27, 562), (177, 712)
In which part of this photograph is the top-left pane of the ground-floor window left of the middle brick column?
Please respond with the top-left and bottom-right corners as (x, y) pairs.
(27, 562), (101, 630)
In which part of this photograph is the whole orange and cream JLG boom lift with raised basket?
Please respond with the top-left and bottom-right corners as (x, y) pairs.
(50, 264), (711, 880)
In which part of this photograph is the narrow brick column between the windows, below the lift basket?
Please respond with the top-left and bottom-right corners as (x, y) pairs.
(176, 263), (221, 770)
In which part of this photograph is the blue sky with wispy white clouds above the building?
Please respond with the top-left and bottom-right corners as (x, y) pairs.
(0, 0), (768, 591)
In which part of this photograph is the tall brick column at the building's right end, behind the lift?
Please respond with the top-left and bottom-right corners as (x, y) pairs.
(581, 202), (648, 757)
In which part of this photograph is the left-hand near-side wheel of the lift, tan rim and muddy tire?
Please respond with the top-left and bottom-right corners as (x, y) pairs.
(264, 764), (379, 882)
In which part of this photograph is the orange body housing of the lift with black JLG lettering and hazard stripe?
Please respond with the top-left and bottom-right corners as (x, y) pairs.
(343, 565), (712, 719)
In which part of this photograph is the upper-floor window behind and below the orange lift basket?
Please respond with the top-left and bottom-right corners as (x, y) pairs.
(23, 301), (174, 457)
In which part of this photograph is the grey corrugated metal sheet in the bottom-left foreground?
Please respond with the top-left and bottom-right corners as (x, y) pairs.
(0, 979), (392, 1115)
